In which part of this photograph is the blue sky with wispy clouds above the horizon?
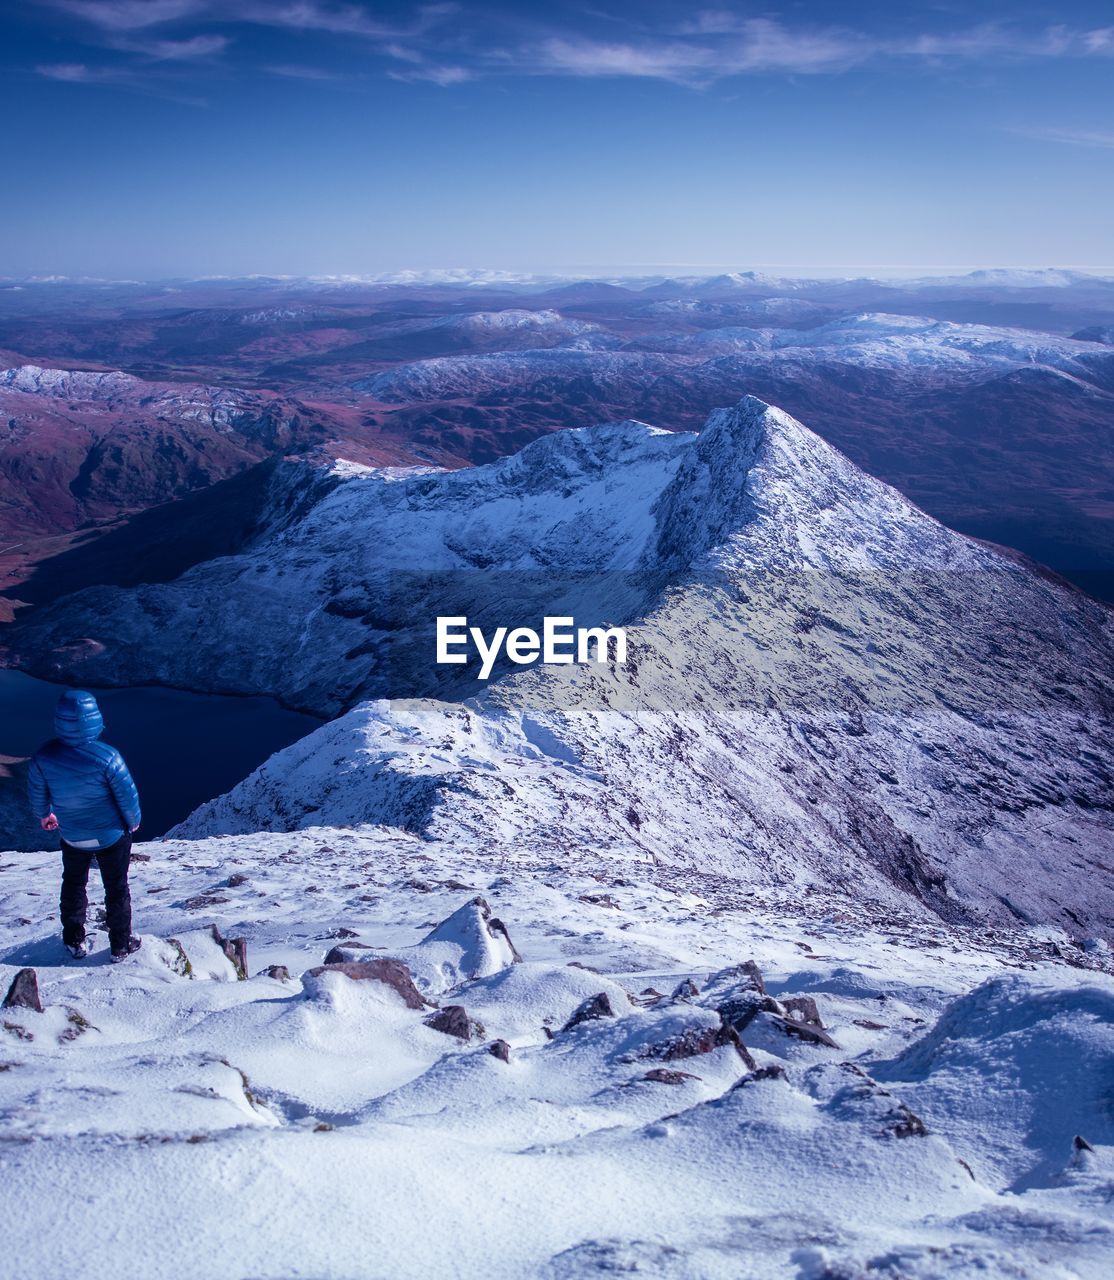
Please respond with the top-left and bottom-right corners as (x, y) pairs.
(0, 0), (1114, 279)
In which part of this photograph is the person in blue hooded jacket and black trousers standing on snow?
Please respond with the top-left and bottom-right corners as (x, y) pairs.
(27, 689), (141, 963)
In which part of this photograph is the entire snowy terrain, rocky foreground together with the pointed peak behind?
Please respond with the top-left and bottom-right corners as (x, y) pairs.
(0, 398), (1114, 1280)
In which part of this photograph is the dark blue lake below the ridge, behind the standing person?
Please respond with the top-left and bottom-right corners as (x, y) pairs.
(0, 669), (323, 849)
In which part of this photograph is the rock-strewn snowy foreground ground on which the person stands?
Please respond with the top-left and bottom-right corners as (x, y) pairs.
(0, 827), (1114, 1280)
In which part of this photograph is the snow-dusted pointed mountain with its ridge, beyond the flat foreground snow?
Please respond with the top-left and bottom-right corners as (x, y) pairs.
(22, 399), (1114, 928)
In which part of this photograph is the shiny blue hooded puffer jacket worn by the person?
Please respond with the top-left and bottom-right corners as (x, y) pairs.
(27, 690), (140, 849)
